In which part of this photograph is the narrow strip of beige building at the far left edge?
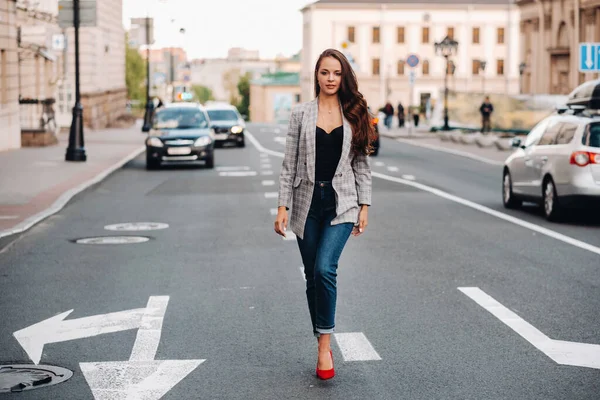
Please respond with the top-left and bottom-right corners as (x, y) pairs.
(0, 0), (21, 151)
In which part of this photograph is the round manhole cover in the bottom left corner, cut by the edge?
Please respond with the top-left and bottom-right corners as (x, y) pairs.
(0, 364), (73, 393)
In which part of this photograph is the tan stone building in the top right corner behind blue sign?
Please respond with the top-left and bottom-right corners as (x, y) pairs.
(517, 0), (600, 94)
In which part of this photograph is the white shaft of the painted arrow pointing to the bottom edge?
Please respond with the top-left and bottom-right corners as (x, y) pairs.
(129, 296), (169, 361)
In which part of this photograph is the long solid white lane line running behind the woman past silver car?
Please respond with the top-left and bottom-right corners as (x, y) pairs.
(249, 131), (600, 255)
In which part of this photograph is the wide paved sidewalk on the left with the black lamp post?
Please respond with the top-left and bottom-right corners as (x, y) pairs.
(0, 124), (145, 247)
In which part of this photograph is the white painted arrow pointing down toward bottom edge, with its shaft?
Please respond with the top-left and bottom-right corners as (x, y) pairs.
(79, 296), (205, 400)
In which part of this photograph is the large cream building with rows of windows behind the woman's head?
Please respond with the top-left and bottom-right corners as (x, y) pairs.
(301, 0), (519, 108)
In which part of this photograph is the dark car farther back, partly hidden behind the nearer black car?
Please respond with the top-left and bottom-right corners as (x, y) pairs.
(206, 104), (246, 147)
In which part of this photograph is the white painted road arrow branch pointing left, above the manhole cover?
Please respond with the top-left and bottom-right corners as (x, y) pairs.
(13, 308), (146, 364)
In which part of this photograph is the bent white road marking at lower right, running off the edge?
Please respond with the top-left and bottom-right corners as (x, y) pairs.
(458, 287), (600, 369)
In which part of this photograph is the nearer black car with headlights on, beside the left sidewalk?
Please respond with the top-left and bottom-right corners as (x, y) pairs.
(146, 103), (215, 169)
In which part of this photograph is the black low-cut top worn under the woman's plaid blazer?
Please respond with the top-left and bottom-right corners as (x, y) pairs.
(315, 126), (344, 181)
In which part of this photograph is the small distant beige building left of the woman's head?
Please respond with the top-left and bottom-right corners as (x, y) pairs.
(250, 72), (300, 123)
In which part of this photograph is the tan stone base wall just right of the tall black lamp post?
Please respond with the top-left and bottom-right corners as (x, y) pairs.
(81, 88), (127, 129)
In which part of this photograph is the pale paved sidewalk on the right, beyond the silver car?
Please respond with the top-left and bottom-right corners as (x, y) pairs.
(380, 126), (513, 165)
